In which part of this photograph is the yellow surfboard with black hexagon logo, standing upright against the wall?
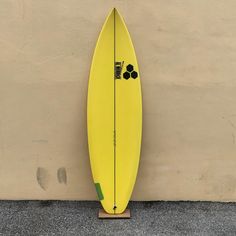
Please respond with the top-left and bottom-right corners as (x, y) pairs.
(87, 9), (142, 214)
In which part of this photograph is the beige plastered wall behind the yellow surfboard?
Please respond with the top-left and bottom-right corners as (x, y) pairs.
(0, 0), (236, 201)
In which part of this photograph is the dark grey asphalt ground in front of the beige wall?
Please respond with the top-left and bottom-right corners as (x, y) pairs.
(0, 201), (236, 236)
